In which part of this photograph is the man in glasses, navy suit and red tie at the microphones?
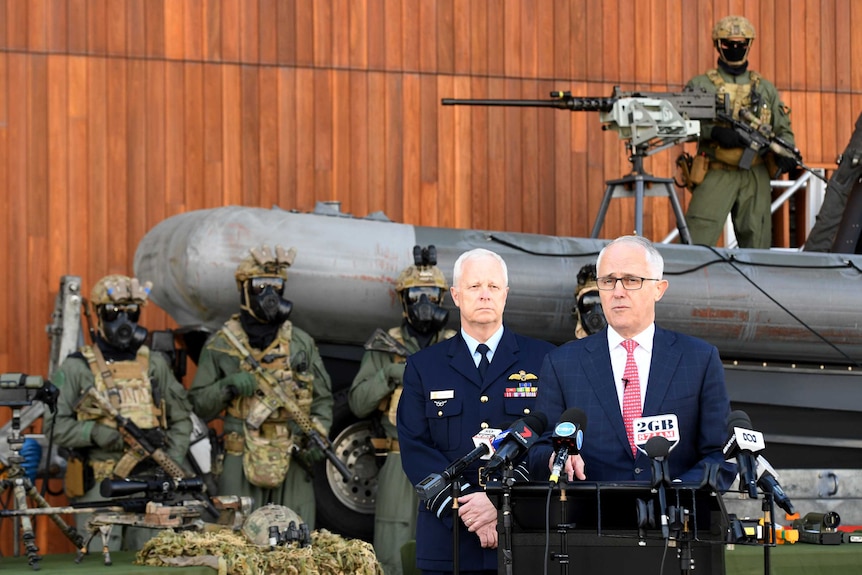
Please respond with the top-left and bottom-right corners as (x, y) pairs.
(530, 236), (734, 489)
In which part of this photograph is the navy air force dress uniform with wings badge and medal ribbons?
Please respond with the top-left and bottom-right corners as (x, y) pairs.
(397, 329), (554, 571)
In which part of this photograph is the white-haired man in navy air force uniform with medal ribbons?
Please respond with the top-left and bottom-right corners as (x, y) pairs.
(397, 249), (553, 575)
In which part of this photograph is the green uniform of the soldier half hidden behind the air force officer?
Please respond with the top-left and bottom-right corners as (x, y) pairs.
(348, 325), (456, 575)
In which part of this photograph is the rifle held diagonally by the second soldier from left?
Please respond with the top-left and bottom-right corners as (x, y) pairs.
(221, 328), (353, 481)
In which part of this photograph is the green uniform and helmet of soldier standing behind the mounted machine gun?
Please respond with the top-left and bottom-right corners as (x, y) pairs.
(685, 16), (793, 249)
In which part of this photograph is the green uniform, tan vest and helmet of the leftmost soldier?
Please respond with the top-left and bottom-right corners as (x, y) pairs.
(45, 276), (192, 552)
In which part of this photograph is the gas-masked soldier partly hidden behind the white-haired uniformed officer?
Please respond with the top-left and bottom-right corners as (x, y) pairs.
(348, 246), (456, 575)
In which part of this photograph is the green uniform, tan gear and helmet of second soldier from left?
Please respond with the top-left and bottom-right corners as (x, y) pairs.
(189, 248), (333, 529)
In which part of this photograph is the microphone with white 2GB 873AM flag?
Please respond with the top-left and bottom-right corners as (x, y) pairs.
(632, 413), (679, 539)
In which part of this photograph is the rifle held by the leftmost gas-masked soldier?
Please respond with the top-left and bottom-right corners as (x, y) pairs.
(75, 386), (189, 478)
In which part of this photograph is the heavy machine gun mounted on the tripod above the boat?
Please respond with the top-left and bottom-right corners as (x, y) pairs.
(441, 86), (727, 156)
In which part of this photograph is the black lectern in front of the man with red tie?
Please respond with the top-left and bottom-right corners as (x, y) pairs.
(486, 481), (727, 575)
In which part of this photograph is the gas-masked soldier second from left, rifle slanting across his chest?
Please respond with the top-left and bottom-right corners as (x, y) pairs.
(189, 246), (333, 529)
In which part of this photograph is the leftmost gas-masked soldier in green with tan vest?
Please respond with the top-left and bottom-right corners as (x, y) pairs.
(46, 275), (192, 551)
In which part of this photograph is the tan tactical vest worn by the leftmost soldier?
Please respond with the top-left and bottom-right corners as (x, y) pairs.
(77, 345), (164, 429)
